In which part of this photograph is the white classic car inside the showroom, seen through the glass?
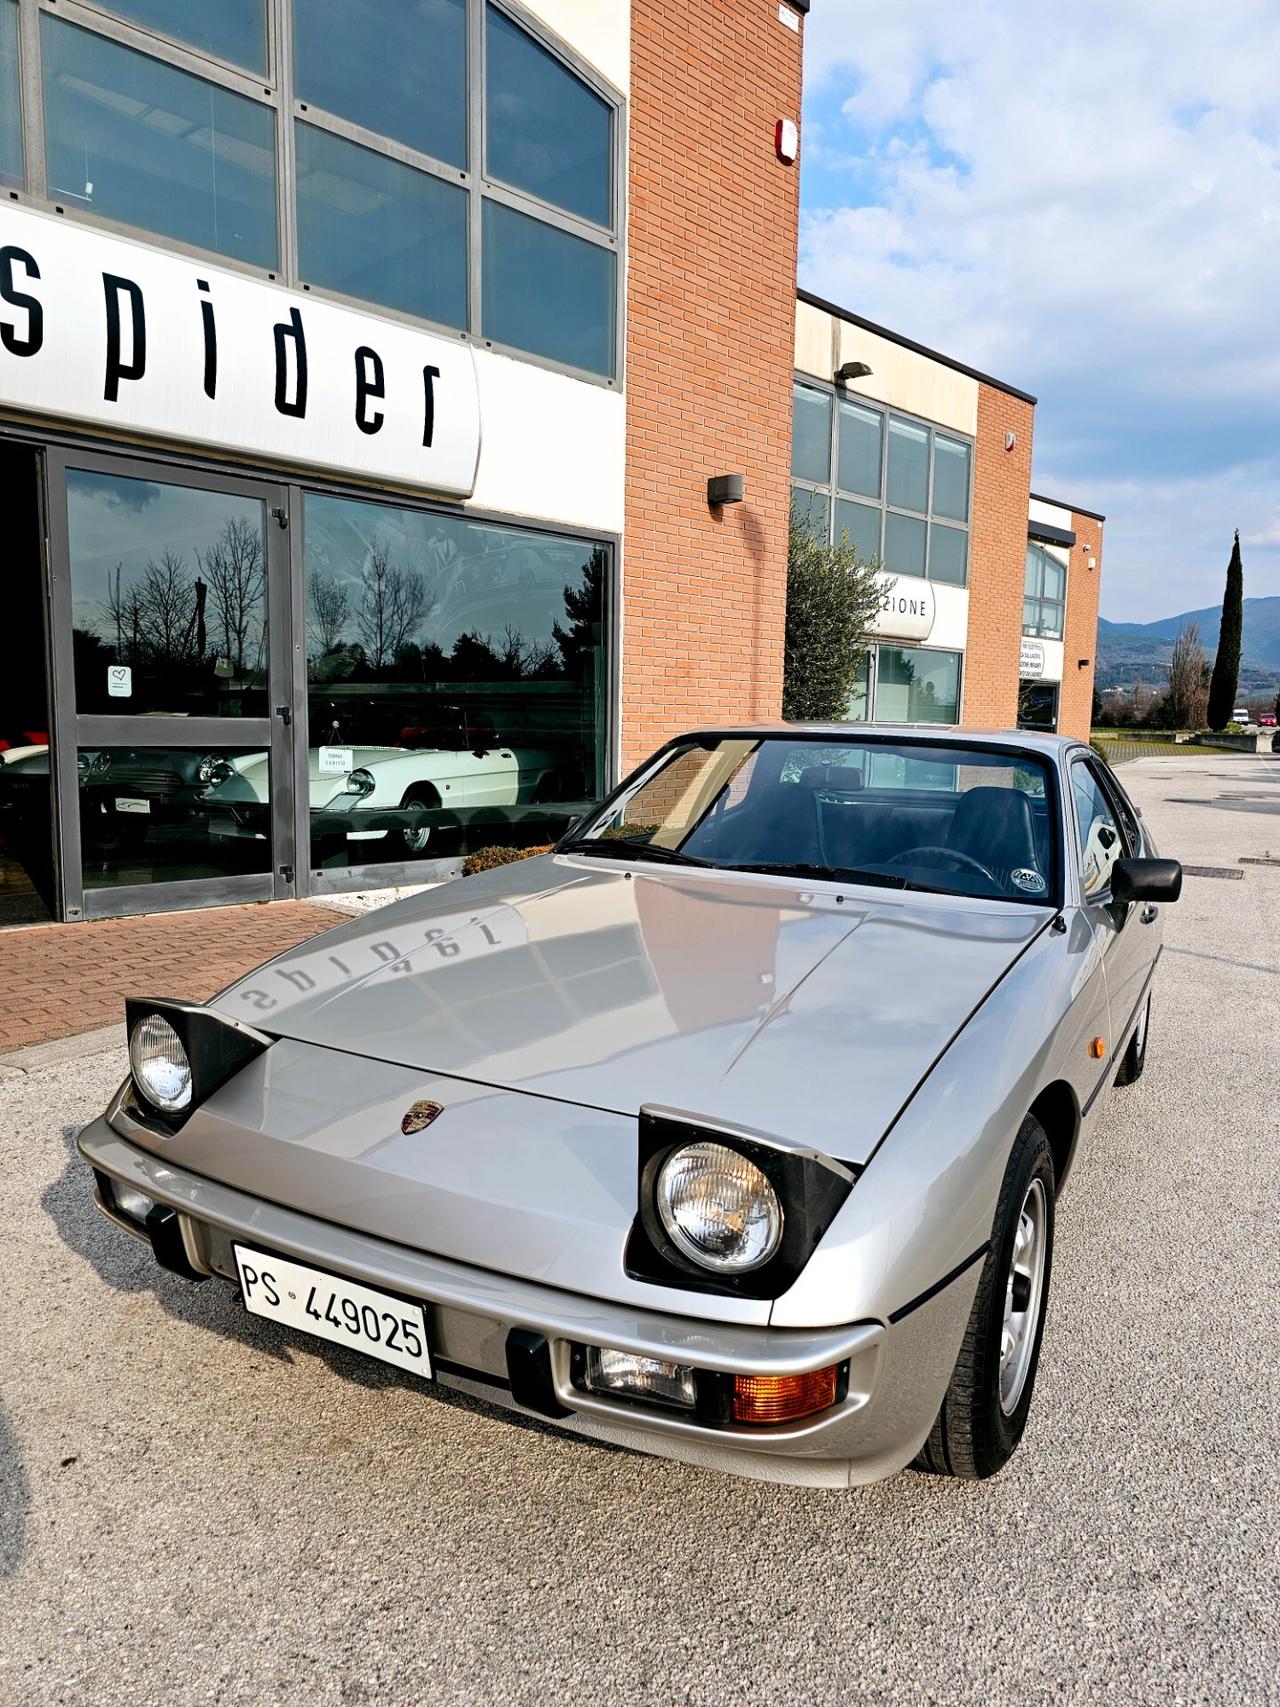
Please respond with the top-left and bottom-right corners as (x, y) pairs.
(205, 707), (563, 855)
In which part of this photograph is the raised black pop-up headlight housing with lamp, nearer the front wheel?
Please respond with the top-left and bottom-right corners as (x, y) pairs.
(625, 1108), (857, 1297)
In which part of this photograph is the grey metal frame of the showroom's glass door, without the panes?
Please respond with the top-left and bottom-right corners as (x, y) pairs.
(44, 444), (299, 920)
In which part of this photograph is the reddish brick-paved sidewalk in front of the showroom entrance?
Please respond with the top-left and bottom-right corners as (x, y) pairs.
(0, 901), (350, 1055)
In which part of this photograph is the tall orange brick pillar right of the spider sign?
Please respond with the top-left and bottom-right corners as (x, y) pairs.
(621, 0), (800, 766)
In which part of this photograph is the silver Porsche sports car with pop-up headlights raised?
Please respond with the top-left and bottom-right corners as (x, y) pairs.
(80, 724), (1181, 1487)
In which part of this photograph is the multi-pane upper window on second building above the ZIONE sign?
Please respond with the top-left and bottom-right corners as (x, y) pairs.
(792, 382), (973, 587)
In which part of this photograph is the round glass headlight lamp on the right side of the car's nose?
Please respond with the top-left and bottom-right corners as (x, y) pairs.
(657, 1142), (782, 1273)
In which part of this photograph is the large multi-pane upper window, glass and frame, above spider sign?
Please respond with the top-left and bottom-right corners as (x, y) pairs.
(0, 0), (621, 384)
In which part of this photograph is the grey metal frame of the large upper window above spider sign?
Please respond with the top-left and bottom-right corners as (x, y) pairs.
(12, 0), (628, 391)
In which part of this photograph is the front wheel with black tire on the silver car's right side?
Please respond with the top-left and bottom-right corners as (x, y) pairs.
(913, 1115), (1055, 1482)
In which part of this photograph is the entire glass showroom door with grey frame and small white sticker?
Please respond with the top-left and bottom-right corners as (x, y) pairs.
(48, 451), (294, 918)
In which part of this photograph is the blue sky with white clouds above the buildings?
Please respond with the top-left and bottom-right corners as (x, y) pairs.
(800, 0), (1280, 621)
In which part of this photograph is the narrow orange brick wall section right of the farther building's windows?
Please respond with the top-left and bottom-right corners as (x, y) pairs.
(961, 386), (1037, 729)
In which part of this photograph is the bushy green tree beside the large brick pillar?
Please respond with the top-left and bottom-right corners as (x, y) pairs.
(782, 497), (893, 722)
